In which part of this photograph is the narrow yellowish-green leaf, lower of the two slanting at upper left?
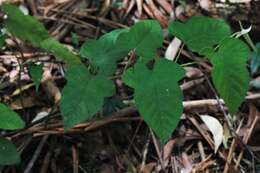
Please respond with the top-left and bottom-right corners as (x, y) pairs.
(40, 38), (81, 65)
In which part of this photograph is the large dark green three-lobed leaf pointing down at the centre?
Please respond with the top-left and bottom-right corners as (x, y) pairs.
(123, 59), (185, 142)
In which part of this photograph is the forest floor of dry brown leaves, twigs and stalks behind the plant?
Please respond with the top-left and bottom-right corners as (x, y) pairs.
(0, 0), (260, 173)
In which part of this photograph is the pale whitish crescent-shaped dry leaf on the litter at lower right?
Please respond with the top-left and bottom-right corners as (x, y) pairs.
(200, 115), (224, 153)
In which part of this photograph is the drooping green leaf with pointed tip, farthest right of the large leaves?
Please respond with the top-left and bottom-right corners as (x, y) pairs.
(210, 38), (249, 114)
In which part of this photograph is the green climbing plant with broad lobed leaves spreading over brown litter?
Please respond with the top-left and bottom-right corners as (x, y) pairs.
(0, 4), (252, 165)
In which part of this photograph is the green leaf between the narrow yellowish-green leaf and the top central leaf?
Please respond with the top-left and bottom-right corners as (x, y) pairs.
(80, 29), (130, 76)
